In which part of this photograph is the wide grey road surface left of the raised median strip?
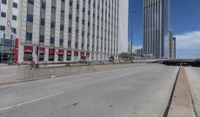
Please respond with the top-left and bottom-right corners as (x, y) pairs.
(0, 65), (178, 117)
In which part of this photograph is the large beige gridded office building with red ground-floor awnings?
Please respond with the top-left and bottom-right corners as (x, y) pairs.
(15, 0), (122, 63)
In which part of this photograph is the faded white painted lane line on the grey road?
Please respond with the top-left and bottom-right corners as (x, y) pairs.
(0, 92), (64, 111)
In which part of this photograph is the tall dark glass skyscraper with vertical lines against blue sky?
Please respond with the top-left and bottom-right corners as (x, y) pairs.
(143, 0), (170, 58)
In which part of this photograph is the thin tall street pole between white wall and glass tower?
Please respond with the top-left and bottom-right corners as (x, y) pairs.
(130, 10), (136, 62)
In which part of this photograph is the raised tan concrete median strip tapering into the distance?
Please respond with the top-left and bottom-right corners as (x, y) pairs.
(167, 67), (195, 117)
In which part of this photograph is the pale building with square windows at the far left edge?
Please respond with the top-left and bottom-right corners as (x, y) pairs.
(0, 0), (19, 62)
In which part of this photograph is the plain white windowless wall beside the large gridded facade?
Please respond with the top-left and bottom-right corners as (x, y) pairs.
(119, 0), (129, 53)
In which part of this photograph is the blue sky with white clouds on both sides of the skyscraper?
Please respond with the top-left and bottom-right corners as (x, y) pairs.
(129, 0), (200, 58)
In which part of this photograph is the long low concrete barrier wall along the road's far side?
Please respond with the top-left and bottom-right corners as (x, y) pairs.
(0, 64), (148, 84)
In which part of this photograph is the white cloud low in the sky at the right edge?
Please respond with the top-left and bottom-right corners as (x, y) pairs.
(175, 31), (200, 57)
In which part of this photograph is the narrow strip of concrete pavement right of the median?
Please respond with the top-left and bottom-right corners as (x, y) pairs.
(186, 67), (200, 117)
